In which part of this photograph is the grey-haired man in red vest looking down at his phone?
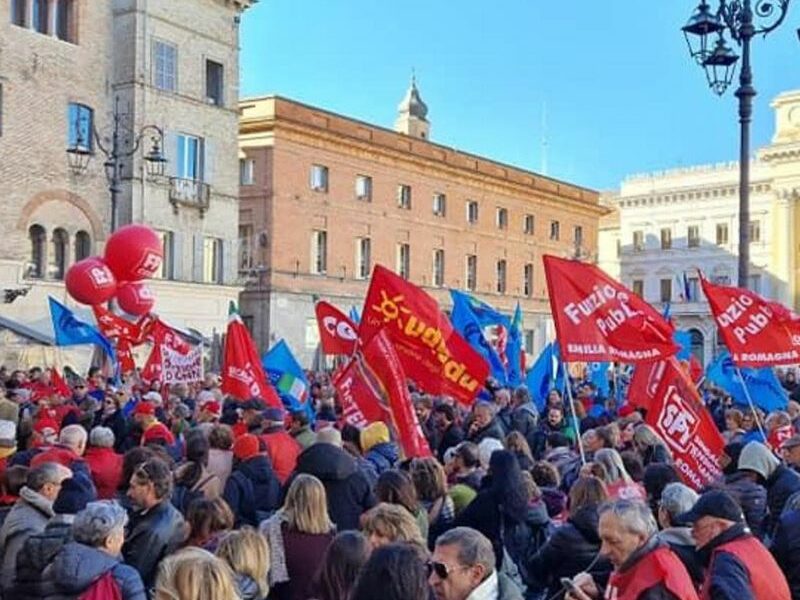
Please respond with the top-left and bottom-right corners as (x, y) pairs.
(566, 500), (698, 600)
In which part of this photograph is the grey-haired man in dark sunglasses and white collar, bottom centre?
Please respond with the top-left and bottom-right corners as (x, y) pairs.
(428, 527), (522, 600)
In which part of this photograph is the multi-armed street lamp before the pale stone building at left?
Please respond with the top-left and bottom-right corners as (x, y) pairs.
(67, 97), (167, 232)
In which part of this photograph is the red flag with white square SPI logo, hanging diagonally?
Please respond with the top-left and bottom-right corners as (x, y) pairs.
(647, 358), (725, 490)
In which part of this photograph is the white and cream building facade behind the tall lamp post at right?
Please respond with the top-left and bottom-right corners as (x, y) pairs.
(600, 92), (800, 363)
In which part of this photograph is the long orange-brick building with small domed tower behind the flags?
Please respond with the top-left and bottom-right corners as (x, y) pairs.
(239, 82), (606, 365)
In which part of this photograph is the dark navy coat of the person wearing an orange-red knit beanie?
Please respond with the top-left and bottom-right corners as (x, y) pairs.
(223, 455), (281, 527)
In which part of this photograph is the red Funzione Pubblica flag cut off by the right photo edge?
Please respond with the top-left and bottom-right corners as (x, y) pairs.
(700, 276), (800, 367)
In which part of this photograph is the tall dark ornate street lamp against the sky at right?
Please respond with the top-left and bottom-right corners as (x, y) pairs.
(681, 0), (800, 287)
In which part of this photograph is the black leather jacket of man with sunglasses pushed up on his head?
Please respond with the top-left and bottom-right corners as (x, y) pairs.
(122, 499), (186, 589)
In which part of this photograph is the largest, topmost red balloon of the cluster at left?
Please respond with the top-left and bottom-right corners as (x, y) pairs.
(105, 225), (164, 281)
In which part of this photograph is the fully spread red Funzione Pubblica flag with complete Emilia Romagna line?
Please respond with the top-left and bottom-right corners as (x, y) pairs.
(543, 256), (678, 363)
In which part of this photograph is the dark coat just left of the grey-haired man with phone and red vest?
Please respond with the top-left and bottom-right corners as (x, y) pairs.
(527, 505), (611, 600)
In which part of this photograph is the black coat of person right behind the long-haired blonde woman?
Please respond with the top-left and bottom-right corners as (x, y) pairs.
(286, 444), (376, 531)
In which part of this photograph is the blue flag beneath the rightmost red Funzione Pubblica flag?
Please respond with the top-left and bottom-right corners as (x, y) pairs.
(706, 350), (789, 413)
